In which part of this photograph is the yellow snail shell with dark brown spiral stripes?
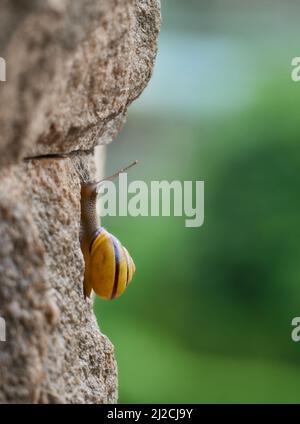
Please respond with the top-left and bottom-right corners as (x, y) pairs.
(86, 227), (135, 299)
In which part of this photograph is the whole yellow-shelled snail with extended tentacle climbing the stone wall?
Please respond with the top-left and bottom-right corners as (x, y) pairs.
(80, 162), (137, 299)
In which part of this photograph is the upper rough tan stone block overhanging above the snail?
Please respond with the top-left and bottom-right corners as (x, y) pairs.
(0, 0), (160, 161)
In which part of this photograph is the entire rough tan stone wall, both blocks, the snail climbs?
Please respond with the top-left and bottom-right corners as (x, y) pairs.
(0, 0), (160, 403)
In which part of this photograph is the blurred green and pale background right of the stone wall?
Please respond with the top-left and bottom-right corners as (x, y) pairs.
(95, 0), (300, 403)
